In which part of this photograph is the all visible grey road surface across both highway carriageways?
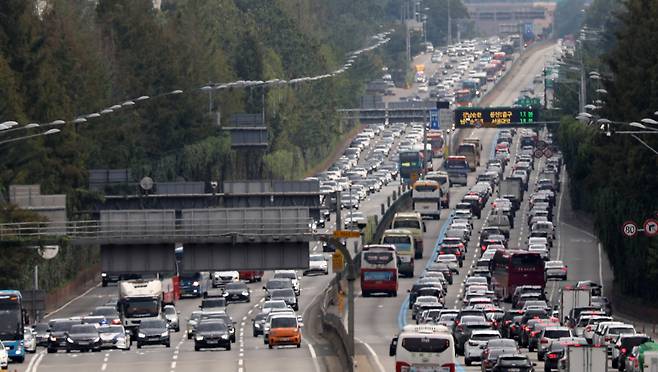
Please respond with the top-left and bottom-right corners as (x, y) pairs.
(10, 40), (612, 372)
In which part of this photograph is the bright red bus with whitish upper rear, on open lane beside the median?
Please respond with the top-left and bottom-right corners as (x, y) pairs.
(361, 244), (398, 297)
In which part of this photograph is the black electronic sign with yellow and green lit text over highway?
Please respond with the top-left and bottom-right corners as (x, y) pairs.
(455, 107), (538, 128)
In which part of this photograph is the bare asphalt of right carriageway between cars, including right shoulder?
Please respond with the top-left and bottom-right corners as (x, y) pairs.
(348, 40), (584, 371)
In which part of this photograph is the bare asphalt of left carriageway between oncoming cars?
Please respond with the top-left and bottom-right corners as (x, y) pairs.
(16, 110), (408, 372)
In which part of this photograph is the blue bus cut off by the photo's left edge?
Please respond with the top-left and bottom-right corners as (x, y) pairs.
(0, 289), (25, 363)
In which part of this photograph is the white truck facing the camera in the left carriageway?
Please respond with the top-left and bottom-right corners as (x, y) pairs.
(117, 279), (163, 331)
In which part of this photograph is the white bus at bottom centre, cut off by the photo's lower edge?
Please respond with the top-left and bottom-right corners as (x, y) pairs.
(389, 324), (457, 372)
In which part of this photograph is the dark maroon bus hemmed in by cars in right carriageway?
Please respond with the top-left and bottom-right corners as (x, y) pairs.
(491, 249), (546, 301)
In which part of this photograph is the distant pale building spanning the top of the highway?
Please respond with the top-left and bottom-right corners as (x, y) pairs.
(465, 0), (556, 37)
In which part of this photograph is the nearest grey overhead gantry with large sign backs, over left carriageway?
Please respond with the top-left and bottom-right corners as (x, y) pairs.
(0, 207), (319, 274)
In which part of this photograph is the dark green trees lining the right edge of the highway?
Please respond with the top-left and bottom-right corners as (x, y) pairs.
(557, 0), (658, 304)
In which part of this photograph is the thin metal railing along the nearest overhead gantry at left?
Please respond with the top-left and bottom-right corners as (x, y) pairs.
(0, 217), (312, 241)
